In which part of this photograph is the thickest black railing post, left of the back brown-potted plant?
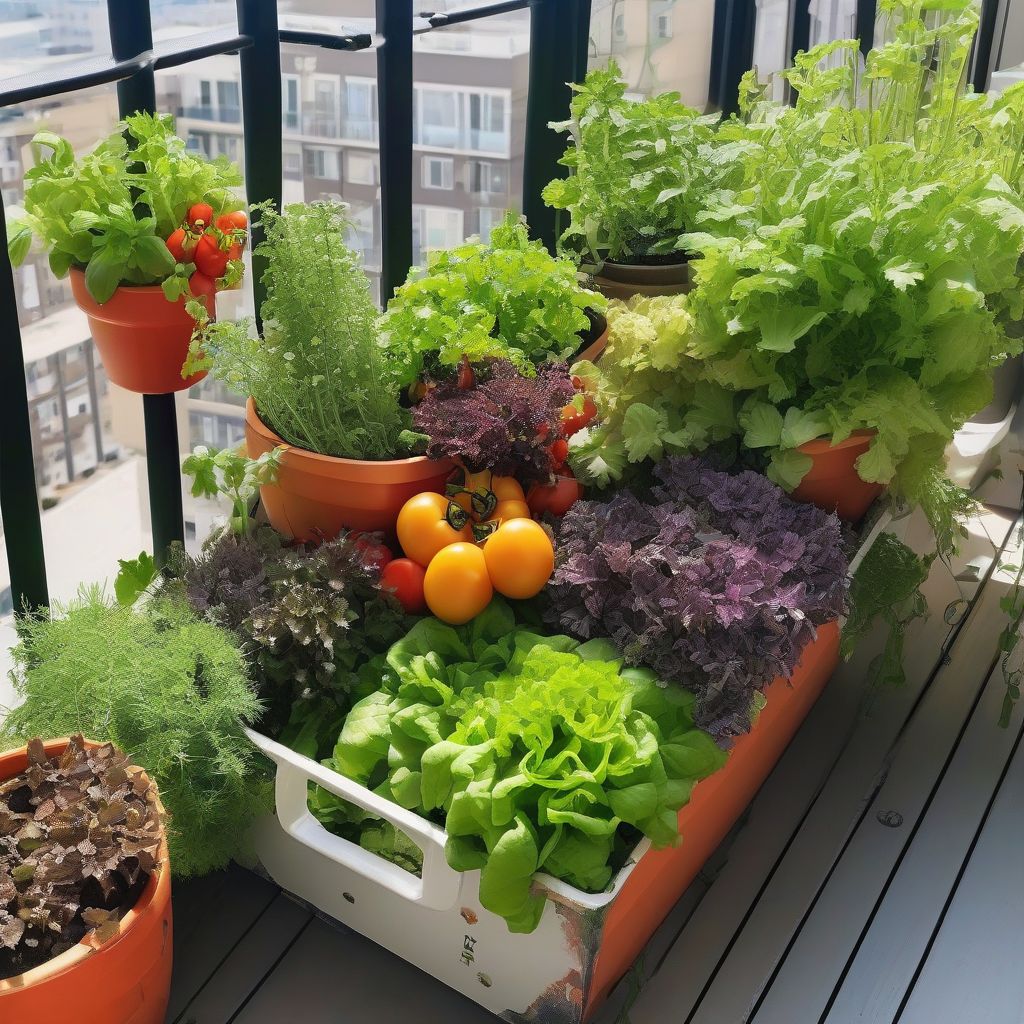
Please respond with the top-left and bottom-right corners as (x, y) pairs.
(522, 0), (590, 252)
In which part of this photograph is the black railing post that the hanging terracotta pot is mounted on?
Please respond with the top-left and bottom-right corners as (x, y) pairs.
(106, 0), (184, 562)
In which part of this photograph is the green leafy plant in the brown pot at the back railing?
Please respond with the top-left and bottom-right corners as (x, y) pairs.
(544, 61), (745, 264)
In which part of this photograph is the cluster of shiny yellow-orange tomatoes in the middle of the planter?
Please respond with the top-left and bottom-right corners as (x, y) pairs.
(389, 474), (555, 625)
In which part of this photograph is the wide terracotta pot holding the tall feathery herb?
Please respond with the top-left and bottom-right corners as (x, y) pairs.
(246, 398), (455, 541)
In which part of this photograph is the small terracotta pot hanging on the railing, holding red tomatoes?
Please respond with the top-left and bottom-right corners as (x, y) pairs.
(71, 267), (216, 394)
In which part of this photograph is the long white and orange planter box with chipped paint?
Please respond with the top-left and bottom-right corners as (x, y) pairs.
(249, 513), (891, 1024)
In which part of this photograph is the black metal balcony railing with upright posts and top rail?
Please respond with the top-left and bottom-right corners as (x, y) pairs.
(0, 0), (823, 609)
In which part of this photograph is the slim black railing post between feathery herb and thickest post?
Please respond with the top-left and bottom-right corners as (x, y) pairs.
(376, 0), (413, 306)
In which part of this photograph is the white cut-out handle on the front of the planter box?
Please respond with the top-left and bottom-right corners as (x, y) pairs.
(246, 729), (462, 910)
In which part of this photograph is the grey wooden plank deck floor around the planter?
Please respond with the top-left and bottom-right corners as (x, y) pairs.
(168, 510), (1024, 1024)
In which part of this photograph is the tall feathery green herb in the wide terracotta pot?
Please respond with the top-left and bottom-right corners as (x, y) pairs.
(181, 203), (410, 460)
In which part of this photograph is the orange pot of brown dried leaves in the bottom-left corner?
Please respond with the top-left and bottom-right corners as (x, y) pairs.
(0, 737), (173, 1024)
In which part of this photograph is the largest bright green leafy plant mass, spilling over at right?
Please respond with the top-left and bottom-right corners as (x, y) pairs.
(575, 0), (1024, 552)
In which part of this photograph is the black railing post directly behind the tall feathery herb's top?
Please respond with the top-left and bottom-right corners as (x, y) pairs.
(236, 0), (282, 324)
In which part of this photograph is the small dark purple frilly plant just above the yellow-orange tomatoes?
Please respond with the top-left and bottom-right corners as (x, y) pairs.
(413, 359), (575, 483)
